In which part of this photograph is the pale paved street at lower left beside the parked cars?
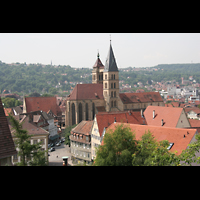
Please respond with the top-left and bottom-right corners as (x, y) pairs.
(48, 142), (72, 166)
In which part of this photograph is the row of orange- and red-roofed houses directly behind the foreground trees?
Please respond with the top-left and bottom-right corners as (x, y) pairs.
(70, 106), (198, 164)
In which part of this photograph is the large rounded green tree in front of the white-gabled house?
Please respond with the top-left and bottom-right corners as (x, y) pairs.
(95, 125), (137, 166)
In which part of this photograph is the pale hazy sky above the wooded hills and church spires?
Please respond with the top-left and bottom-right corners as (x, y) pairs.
(0, 33), (200, 68)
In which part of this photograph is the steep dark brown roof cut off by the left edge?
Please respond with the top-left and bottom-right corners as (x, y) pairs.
(0, 98), (17, 159)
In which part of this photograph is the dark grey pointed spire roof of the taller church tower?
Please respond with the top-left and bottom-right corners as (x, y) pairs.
(104, 44), (118, 72)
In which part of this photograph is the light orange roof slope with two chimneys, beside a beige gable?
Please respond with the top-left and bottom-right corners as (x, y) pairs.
(144, 106), (183, 128)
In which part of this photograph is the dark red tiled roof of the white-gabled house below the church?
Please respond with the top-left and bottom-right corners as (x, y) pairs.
(96, 111), (147, 136)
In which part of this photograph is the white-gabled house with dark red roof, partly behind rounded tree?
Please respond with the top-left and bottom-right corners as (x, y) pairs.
(91, 110), (146, 160)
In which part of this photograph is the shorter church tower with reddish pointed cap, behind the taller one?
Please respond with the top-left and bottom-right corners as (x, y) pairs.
(92, 52), (104, 84)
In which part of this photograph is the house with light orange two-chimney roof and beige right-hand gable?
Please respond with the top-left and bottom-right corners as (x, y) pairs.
(144, 106), (190, 128)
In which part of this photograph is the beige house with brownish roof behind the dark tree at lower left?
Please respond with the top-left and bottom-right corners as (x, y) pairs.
(9, 115), (49, 164)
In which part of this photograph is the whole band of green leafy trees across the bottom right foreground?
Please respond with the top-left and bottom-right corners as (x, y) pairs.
(94, 125), (200, 166)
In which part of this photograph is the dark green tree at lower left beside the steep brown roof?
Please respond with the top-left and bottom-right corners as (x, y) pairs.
(9, 114), (47, 166)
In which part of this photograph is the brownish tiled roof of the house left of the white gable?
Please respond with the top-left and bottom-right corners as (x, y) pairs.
(71, 121), (93, 135)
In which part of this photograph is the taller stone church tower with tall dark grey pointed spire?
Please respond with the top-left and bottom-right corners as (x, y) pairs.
(103, 41), (119, 112)
